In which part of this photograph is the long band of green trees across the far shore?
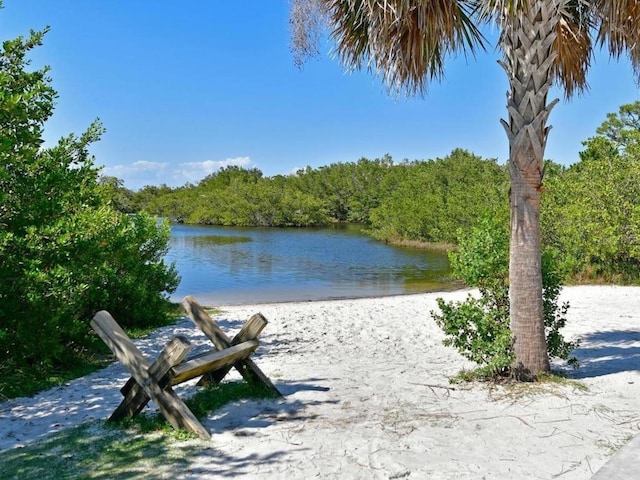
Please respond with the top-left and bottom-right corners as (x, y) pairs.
(131, 149), (508, 243)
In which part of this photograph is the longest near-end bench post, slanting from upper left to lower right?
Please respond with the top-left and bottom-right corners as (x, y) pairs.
(91, 310), (211, 440)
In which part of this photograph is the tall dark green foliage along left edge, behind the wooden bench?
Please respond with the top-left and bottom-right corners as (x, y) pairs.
(0, 32), (178, 385)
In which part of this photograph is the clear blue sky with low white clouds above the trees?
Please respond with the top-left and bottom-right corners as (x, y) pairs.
(0, 0), (640, 189)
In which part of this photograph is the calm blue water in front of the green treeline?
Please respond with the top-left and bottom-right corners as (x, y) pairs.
(167, 225), (451, 305)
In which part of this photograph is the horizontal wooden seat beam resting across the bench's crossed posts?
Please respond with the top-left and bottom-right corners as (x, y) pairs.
(170, 340), (260, 385)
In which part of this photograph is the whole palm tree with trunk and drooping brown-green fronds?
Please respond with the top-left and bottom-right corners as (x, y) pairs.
(291, 0), (640, 378)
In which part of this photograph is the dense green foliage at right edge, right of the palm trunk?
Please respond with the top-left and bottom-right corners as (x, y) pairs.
(543, 102), (640, 282)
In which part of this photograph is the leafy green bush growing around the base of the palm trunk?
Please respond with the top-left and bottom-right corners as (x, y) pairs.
(431, 214), (577, 378)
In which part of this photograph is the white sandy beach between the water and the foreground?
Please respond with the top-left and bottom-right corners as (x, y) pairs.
(0, 286), (640, 480)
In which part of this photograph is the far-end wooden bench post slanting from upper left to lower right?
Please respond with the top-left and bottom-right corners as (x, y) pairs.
(182, 296), (282, 397)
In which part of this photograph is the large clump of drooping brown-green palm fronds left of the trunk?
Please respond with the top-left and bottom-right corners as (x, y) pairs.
(324, 0), (484, 94)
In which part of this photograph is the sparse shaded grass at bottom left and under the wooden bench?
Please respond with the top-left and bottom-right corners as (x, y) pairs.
(0, 382), (280, 480)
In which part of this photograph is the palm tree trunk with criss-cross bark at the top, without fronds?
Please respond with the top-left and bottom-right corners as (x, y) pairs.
(500, 0), (561, 379)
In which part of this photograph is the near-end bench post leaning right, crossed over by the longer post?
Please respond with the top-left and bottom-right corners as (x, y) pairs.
(109, 335), (192, 421)
